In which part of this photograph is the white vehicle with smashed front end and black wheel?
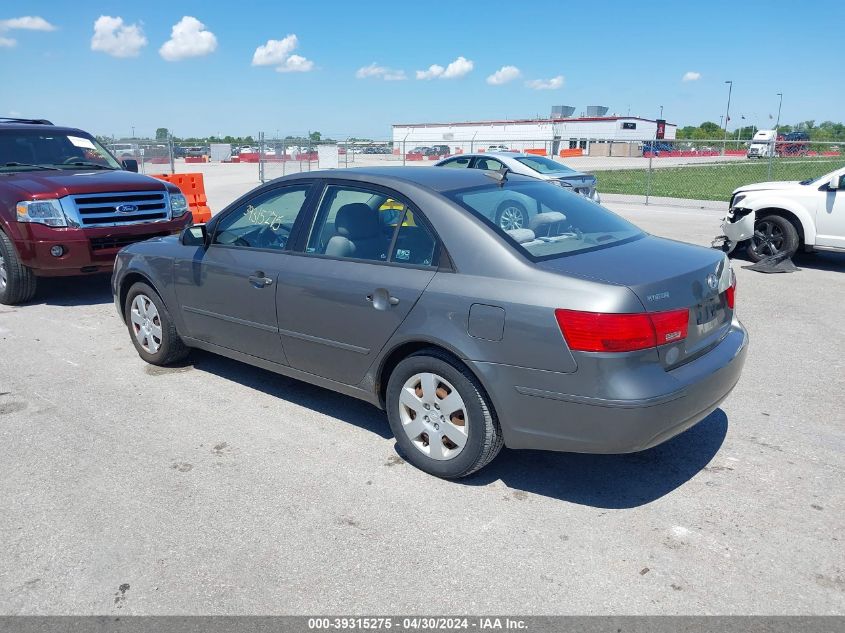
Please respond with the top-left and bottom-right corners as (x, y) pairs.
(713, 168), (845, 262)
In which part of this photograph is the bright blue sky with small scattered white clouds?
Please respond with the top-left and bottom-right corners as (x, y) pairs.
(0, 0), (845, 138)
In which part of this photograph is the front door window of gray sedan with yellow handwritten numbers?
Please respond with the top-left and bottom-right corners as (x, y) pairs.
(214, 185), (310, 250)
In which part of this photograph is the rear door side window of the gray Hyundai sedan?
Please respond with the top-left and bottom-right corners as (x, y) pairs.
(306, 185), (436, 266)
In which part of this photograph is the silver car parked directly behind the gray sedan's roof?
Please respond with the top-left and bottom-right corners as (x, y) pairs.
(434, 151), (601, 230)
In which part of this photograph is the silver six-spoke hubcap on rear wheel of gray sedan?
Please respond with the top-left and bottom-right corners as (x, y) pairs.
(399, 372), (468, 461)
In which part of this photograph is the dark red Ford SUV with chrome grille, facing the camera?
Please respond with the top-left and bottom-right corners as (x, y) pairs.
(0, 119), (191, 305)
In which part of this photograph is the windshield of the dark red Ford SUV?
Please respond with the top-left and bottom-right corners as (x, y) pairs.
(0, 126), (121, 171)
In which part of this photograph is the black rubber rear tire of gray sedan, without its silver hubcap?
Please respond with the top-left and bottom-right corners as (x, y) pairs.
(386, 349), (504, 479)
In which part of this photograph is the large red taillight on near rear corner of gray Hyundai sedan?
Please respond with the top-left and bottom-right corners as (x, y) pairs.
(555, 309), (689, 352)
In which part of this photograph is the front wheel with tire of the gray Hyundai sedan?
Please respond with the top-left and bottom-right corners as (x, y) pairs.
(123, 282), (190, 365)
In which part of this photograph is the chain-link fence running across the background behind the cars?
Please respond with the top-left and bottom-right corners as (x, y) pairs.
(106, 133), (845, 206)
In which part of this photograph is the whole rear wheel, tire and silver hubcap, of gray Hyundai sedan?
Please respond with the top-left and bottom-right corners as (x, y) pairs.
(386, 349), (503, 479)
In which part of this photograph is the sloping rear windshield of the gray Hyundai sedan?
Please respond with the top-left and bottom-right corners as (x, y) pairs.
(444, 181), (645, 260)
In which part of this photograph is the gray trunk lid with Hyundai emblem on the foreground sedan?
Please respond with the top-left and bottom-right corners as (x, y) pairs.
(537, 235), (733, 369)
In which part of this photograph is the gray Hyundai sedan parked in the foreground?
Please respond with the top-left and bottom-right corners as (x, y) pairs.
(112, 167), (748, 478)
